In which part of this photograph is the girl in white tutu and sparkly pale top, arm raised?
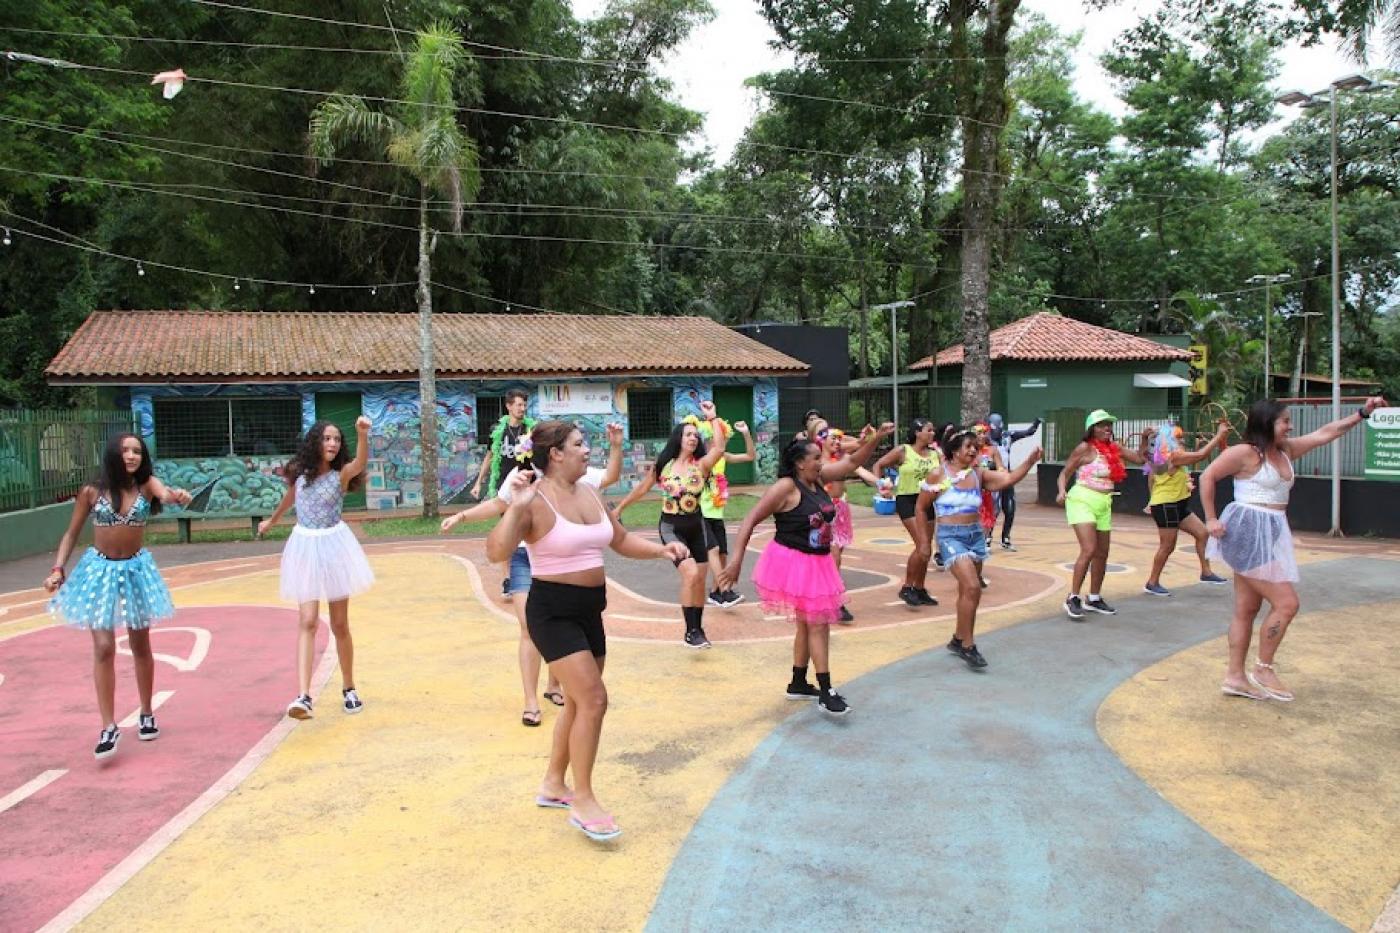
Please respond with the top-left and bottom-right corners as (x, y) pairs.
(258, 415), (374, 719)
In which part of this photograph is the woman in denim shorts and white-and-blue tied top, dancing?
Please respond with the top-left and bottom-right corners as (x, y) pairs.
(914, 429), (1040, 670)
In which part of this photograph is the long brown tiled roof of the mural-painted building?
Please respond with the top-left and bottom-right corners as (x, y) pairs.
(45, 311), (809, 385)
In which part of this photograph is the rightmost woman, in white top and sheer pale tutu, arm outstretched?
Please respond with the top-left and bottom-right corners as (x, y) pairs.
(1201, 396), (1386, 702)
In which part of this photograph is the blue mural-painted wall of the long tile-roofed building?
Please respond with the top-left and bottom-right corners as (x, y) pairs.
(129, 377), (778, 514)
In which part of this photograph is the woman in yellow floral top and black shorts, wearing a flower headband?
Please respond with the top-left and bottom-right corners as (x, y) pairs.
(617, 401), (724, 649)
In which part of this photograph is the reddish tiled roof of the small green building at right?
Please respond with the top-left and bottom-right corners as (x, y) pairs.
(909, 311), (1191, 370)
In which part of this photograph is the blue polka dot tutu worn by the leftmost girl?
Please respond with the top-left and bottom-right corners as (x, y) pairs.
(49, 548), (175, 630)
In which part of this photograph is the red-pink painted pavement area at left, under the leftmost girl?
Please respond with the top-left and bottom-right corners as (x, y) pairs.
(0, 607), (328, 932)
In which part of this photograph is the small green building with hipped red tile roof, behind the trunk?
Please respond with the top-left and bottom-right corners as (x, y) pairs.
(910, 311), (1191, 423)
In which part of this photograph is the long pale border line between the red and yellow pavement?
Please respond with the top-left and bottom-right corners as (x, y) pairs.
(39, 607), (336, 933)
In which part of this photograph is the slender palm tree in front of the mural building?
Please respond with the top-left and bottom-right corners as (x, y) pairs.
(307, 24), (480, 518)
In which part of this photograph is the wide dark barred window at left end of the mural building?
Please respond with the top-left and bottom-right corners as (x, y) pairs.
(154, 395), (301, 459)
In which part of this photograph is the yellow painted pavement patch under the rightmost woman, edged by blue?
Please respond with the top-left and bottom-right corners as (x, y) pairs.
(1098, 599), (1400, 930)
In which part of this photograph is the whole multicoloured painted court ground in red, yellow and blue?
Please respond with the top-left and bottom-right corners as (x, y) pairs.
(0, 507), (1400, 930)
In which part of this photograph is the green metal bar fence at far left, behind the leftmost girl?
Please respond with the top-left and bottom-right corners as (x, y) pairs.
(0, 409), (132, 511)
